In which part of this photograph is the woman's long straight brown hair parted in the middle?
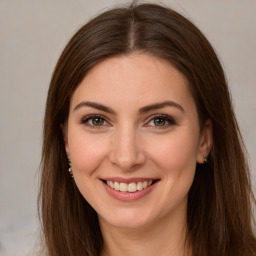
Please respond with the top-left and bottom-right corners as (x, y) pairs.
(39, 4), (256, 256)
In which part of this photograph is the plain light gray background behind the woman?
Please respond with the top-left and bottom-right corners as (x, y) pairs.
(0, 0), (256, 256)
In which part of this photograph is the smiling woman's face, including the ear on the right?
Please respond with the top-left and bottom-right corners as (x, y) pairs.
(65, 54), (211, 228)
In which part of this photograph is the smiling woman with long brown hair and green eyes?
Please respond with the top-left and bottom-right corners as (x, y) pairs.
(40, 4), (256, 256)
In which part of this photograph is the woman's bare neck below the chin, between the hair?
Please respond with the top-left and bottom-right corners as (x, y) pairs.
(100, 205), (191, 256)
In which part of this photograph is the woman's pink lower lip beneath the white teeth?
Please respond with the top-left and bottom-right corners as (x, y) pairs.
(102, 182), (157, 202)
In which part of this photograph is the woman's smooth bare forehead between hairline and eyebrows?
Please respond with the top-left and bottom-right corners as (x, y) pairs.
(71, 53), (194, 113)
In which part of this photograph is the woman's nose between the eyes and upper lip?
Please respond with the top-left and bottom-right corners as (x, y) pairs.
(110, 125), (146, 171)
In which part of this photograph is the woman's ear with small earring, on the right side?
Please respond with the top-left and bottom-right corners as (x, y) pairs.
(197, 119), (213, 164)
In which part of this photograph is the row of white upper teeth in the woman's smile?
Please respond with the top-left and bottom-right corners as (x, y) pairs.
(107, 180), (153, 192)
